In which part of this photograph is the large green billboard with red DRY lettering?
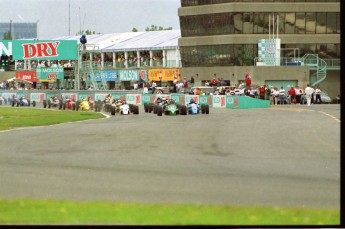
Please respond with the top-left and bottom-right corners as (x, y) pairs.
(11, 40), (78, 60)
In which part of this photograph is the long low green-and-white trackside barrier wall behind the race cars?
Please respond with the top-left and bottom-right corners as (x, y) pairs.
(0, 91), (270, 109)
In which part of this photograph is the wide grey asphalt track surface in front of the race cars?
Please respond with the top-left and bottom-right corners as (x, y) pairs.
(0, 104), (340, 209)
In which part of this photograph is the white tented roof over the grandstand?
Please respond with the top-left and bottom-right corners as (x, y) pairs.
(53, 30), (181, 52)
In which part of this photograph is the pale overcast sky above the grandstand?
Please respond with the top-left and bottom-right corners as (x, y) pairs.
(0, 0), (181, 39)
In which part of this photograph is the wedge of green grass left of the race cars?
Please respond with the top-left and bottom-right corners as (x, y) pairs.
(0, 107), (104, 130)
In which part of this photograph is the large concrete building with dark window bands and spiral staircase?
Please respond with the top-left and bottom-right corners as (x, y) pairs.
(178, 0), (340, 98)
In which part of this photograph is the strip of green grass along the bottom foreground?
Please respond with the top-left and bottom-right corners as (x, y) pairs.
(0, 199), (340, 226)
